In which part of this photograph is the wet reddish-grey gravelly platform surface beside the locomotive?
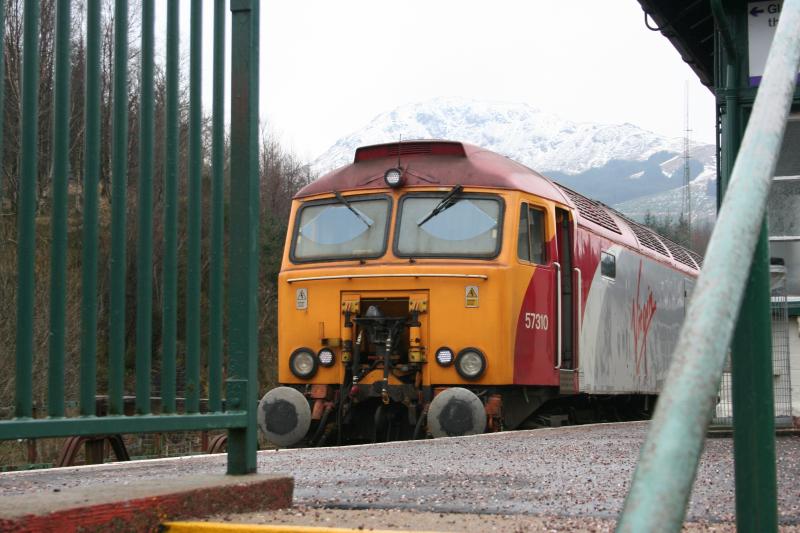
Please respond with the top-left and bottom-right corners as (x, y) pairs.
(0, 422), (800, 525)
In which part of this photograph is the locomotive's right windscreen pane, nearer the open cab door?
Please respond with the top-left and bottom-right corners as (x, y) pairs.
(397, 194), (502, 257)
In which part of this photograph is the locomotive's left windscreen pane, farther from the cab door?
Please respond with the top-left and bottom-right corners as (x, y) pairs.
(292, 196), (389, 261)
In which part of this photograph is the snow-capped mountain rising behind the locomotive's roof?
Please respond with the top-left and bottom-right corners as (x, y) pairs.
(313, 98), (716, 218)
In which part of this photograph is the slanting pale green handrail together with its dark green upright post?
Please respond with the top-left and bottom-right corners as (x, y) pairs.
(618, 0), (800, 532)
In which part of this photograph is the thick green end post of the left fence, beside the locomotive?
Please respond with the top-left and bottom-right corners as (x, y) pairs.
(226, 0), (260, 475)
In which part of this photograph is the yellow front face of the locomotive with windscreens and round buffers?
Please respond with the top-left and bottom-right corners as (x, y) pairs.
(259, 179), (505, 445)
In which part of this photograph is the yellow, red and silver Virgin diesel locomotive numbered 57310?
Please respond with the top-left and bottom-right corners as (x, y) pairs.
(258, 141), (702, 446)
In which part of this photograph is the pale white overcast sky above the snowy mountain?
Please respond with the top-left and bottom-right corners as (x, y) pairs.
(157, 0), (714, 160)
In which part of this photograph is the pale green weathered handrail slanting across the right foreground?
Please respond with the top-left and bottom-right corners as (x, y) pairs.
(617, 0), (800, 532)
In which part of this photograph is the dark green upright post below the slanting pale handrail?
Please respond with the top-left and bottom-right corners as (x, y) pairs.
(731, 223), (778, 533)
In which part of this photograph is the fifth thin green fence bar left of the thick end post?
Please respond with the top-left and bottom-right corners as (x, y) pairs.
(108, 0), (128, 415)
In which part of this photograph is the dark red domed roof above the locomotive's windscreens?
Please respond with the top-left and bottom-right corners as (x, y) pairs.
(295, 141), (570, 205)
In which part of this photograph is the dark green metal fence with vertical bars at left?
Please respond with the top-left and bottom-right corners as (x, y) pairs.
(0, 0), (259, 474)
